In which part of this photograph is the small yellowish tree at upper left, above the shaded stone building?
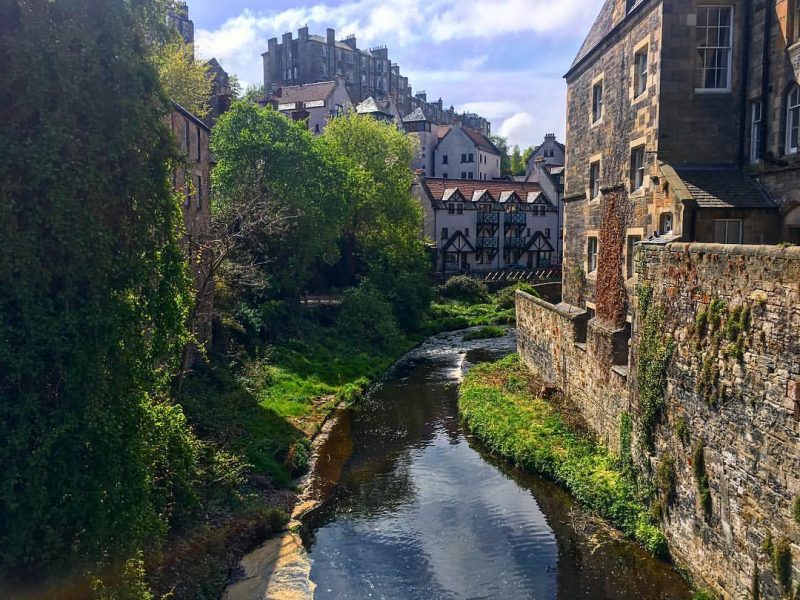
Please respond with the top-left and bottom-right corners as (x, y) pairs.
(153, 37), (214, 119)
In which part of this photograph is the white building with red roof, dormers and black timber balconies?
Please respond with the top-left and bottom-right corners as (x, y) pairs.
(414, 177), (561, 273)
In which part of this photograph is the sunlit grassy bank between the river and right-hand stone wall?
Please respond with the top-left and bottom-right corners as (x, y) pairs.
(459, 355), (666, 555)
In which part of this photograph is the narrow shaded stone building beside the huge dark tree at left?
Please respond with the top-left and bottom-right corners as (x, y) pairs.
(169, 103), (214, 358)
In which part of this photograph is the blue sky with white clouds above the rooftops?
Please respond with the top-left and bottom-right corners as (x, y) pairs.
(192, 0), (603, 148)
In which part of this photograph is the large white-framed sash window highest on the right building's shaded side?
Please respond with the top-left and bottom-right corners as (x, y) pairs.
(696, 6), (733, 91)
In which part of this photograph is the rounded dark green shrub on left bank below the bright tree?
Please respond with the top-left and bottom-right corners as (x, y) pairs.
(336, 285), (402, 348)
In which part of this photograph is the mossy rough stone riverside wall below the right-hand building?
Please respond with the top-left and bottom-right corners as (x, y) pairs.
(517, 243), (800, 598)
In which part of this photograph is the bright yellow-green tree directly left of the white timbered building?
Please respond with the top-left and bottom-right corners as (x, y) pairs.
(319, 114), (431, 329)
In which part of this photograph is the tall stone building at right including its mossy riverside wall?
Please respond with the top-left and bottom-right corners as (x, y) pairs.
(517, 0), (800, 598)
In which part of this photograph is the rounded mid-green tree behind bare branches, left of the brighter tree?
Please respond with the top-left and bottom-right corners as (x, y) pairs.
(212, 101), (349, 298)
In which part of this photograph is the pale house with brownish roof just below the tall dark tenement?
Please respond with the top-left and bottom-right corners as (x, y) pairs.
(268, 79), (353, 134)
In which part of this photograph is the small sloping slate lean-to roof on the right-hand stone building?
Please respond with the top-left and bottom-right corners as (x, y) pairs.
(675, 165), (775, 208)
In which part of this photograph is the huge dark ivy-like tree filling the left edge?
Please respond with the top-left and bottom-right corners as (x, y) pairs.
(0, 0), (197, 576)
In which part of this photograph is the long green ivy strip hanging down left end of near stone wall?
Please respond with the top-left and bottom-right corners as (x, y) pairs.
(636, 285), (674, 452)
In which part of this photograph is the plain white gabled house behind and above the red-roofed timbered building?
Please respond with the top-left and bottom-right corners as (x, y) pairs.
(432, 124), (500, 181)
